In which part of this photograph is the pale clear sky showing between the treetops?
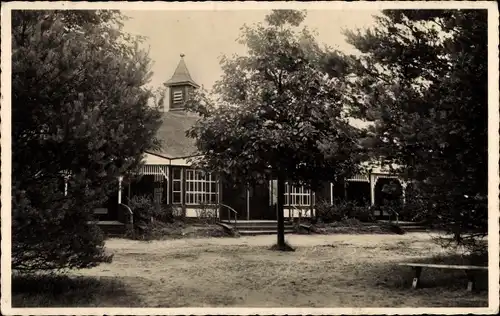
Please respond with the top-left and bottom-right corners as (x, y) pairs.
(123, 10), (378, 94)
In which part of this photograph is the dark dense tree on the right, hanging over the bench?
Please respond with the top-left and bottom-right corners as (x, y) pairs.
(346, 10), (488, 253)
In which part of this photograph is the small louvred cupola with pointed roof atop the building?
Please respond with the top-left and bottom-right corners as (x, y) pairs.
(165, 54), (200, 111)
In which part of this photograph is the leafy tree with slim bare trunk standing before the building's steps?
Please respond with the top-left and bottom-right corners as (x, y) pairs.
(188, 10), (359, 250)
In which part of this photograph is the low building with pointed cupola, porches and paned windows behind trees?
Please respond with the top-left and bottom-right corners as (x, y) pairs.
(96, 55), (405, 220)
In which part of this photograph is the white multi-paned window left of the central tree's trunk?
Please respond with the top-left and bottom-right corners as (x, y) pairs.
(186, 169), (219, 205)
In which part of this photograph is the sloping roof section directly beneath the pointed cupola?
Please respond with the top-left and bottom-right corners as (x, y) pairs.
(151, 111), (198, 158)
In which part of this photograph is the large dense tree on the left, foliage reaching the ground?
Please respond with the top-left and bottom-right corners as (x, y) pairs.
(12, 10), (161, 272)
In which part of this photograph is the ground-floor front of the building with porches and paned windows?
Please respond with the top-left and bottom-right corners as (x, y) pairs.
(90, 164), (406, 235)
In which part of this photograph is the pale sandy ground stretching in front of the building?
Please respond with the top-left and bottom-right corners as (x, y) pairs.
(36, 233), (487, 307)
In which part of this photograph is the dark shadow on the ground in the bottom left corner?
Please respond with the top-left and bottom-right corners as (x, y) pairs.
(12, 275), (145, 307)
